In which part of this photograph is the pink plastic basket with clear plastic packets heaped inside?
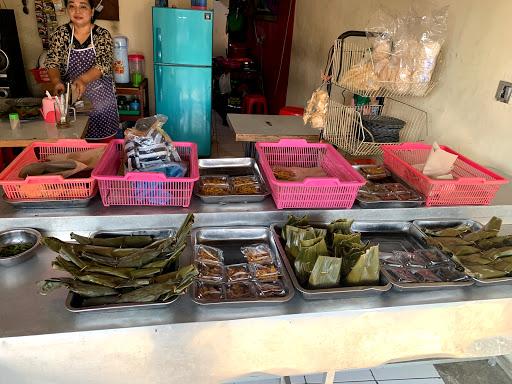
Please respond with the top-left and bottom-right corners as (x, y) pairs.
(92, 139), (199, 207)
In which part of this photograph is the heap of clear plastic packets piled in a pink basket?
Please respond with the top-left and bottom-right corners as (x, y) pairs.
(124, 115), (187, 177)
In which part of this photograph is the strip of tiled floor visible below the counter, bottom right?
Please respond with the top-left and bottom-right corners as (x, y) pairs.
(230, 360), (512, 384)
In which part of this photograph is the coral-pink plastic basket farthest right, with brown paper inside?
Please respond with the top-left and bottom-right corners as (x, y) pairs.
(382, 143), (508, 206)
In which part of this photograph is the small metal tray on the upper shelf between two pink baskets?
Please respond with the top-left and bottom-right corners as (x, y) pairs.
(194, 157), (270, 204)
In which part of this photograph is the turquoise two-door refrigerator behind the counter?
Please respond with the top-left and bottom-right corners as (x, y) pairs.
(153, 7), (213, 157)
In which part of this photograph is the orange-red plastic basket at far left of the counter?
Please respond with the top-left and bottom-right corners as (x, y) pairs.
(0, 139), (107, 200)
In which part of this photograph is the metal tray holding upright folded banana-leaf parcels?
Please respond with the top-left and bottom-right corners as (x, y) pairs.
(271, 223), (392, 300)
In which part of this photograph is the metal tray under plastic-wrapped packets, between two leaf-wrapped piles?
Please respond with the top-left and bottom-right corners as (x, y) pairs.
(191, 226), (295, 308)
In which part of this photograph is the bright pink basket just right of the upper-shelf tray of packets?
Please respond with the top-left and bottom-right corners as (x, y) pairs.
(256, 139), (365, 209)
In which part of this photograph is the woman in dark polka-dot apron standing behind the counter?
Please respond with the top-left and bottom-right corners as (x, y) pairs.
(45, 0), (119, 140)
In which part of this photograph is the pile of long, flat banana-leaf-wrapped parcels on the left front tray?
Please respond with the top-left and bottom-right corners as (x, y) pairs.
(38, 215), (199, 305)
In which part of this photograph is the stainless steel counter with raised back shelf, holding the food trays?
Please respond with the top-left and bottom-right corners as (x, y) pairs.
(0, 187), (512, 384)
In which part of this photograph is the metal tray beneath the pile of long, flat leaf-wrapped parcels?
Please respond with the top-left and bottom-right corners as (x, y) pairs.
(66, 228), (179, 313)
